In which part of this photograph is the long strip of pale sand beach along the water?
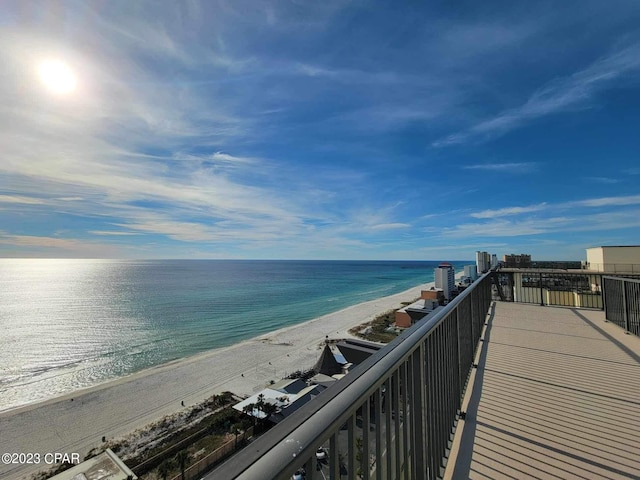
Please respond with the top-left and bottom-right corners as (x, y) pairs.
(0, 283), (440, 478)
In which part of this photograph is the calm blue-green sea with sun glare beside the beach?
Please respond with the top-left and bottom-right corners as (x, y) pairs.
(0, 259), (469, 410)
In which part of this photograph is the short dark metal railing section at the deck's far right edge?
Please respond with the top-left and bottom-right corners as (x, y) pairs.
(603, 276), (640, 336)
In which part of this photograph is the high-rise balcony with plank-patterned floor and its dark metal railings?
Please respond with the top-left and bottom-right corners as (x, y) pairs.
(207, 274), (640, 480)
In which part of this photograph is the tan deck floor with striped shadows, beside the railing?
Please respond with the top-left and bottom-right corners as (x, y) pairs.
(445, 302), (640, 479)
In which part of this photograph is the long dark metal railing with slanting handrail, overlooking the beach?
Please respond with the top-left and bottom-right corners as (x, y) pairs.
(206, 274), (491, 480)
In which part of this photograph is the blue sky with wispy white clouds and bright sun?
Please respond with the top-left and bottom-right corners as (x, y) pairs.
(0, 0), (640, 260)
